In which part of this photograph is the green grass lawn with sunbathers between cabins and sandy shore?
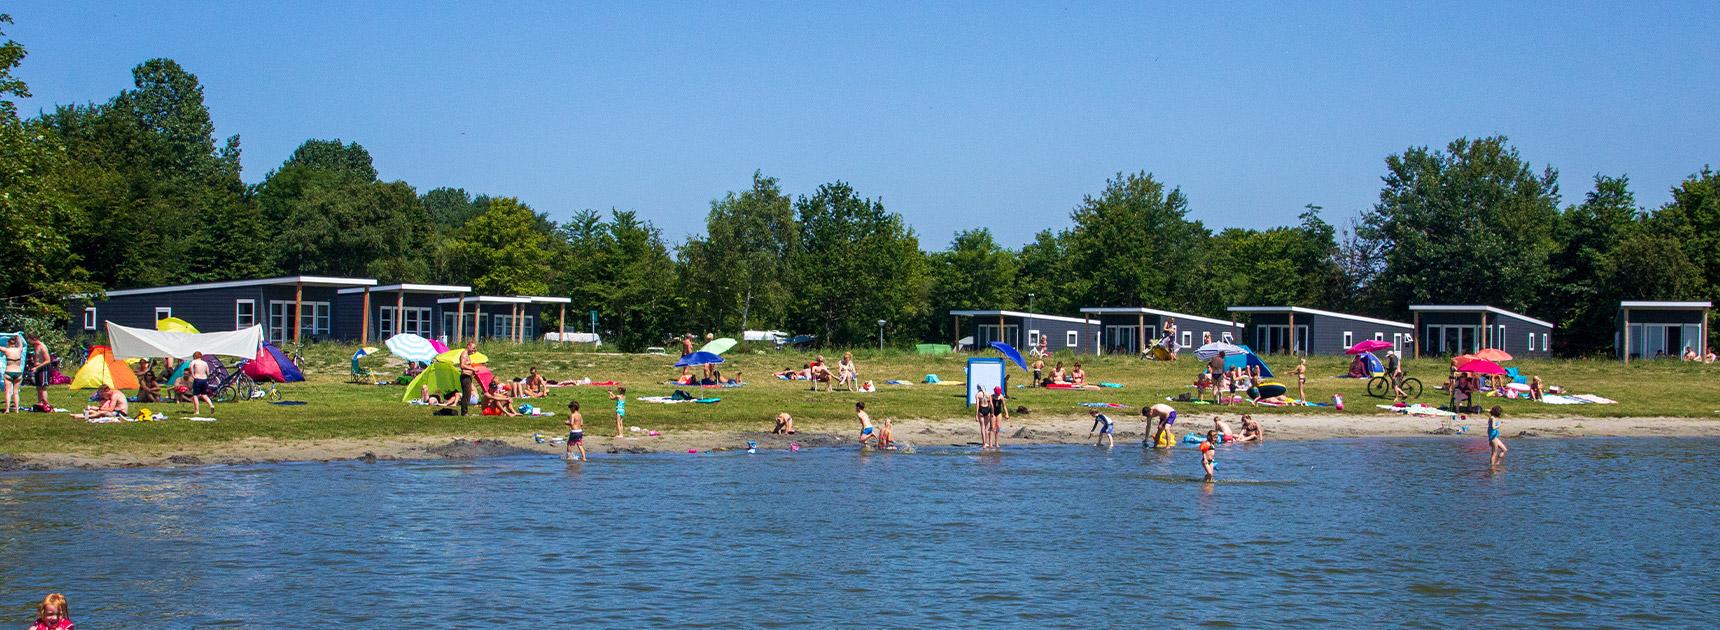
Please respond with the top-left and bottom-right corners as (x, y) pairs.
(0, 343), (1720, 454)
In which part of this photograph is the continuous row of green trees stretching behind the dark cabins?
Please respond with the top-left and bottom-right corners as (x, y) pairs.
(0, 15), (1720, 355)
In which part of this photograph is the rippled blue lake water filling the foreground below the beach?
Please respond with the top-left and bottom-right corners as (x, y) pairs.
(0, 439), (1720, 628)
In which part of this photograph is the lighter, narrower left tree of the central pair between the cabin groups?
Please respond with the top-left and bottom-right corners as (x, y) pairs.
(681, 172), (800, 330)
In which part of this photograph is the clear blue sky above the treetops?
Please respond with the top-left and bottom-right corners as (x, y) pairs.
(7, 2), (1720, 248)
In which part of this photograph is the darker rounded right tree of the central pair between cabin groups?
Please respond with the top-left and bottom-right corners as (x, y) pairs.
(789, 182), (931, 346)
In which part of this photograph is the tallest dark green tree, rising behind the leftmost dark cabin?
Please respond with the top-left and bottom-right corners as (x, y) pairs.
(43, 59), (273, 287)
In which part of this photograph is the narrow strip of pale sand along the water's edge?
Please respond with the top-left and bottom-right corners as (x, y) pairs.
(0, 413), (1720, 470)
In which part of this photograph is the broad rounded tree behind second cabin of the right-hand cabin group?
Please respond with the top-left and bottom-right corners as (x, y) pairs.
(1066, 172), (1207, 310)
